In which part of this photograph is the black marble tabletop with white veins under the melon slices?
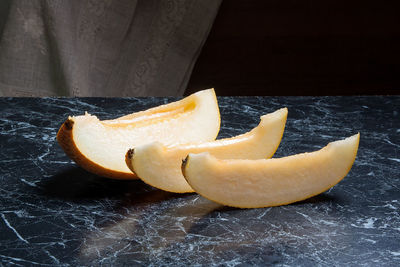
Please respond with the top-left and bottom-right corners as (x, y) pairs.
(0, 96), (400, 266)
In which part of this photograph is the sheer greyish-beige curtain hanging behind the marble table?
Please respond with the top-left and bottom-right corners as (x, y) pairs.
(0, 0), (222, 96)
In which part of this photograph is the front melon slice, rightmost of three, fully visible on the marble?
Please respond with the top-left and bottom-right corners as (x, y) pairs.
(182, 134), (360, 208)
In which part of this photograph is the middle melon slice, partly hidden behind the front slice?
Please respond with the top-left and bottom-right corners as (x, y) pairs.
(126, 108), (287, 193)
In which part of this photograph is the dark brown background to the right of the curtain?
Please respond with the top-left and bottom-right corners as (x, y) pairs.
(186, 0), (400, 95)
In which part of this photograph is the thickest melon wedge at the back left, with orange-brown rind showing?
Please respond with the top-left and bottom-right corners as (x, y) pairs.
(57, 89), (220, 179)
